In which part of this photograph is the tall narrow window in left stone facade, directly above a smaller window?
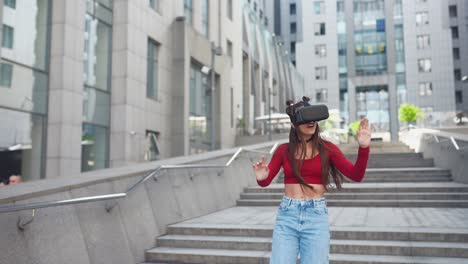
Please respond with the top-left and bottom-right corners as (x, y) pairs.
(146, 38), (159, 99)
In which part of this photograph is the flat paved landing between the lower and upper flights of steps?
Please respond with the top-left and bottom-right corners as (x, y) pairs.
(175, 206), (468, 231)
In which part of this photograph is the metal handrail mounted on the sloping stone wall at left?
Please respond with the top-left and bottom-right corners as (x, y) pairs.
(0, 143), (278, 220)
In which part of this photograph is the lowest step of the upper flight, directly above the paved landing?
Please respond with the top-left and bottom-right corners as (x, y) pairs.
(237, 199), (468, 208)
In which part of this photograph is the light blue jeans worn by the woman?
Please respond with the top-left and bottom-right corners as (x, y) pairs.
(270, 196), (330, 264)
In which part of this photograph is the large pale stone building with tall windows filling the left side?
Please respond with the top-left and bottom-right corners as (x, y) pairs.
(0, 0), (297, 180)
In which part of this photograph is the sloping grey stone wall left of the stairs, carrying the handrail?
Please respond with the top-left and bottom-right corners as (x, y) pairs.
(0, 143), (273, 264)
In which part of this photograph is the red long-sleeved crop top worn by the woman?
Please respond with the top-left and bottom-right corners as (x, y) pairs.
(257, 142), (369, 187)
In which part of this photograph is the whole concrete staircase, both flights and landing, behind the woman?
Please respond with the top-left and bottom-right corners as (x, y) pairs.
(146, 144), (468, 264)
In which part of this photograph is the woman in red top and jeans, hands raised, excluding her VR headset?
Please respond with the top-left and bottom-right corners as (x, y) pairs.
(253, 97), (371, 264)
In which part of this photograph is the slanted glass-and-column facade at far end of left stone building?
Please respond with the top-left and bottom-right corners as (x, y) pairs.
(243, 0), (304, 134)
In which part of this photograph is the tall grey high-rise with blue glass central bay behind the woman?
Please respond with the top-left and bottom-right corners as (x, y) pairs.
(296, 0), (467, 140)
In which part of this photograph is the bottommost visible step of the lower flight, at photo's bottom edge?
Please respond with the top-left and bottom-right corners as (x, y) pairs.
(146, 247), (468, 264)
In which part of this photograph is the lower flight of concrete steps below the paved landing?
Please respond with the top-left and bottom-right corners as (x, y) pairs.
(146, 224), (468, 264)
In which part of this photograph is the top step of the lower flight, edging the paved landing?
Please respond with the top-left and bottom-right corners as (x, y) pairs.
(167, 224), (468, 243)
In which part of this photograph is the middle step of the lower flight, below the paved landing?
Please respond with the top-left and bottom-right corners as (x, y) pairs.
(157, 235), (468, 258)
